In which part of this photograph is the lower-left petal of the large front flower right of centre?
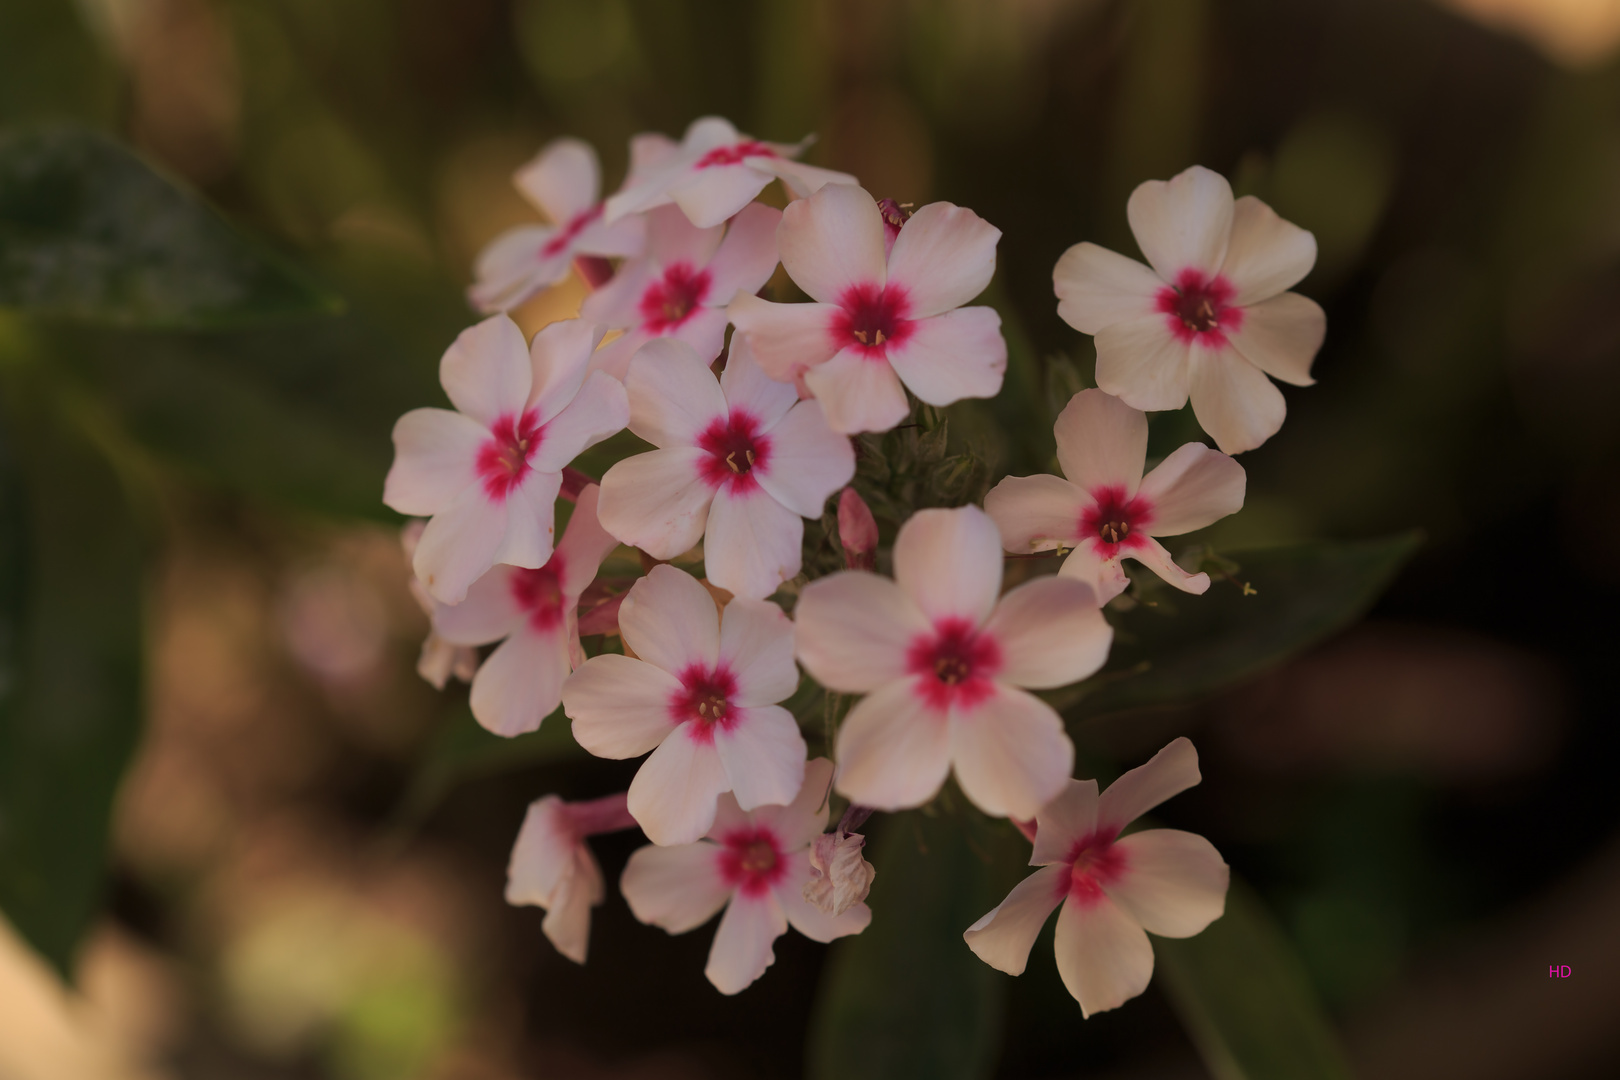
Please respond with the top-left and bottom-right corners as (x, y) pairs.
(836, 678), (951, 810)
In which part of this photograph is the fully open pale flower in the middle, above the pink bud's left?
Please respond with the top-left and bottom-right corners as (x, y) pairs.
(601, 342), (855, 599)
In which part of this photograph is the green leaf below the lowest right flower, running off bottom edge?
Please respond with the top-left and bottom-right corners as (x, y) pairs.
(1153, 881), (1351, 1080)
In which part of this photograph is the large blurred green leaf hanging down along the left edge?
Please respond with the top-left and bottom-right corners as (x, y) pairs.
(0, 402), (141, 975)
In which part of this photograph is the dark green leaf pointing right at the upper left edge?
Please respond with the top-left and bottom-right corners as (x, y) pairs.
(0, 128), (342, 327)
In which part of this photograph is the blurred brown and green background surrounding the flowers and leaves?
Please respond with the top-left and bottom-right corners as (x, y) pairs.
(0, 0), (1620, 1080)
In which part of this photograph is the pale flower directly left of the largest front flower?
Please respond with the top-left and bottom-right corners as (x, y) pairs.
(562, 565), (805, 844)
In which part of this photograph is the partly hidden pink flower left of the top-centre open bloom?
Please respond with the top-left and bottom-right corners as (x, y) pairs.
(580, 202), (782, 379)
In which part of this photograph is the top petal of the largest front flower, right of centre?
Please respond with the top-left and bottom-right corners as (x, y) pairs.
(894, 505), (1001, 627)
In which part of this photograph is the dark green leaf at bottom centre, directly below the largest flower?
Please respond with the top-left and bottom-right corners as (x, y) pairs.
(807, 811), (1016, 1080)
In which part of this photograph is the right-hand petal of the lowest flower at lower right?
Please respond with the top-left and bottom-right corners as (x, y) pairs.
(1103, 829), (1231, 938)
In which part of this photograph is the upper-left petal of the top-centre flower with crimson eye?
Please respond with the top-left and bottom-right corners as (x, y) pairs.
(776, 183), (885, 304)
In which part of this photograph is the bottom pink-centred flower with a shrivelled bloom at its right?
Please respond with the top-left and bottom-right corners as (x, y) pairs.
(619, 758), (872, 994)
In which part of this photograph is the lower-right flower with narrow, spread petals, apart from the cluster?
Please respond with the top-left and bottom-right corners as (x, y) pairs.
(962, 738), (1228, 1017)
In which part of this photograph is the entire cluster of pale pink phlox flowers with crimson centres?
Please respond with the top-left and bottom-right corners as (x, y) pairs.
(384, 117), (1324, 1015)
